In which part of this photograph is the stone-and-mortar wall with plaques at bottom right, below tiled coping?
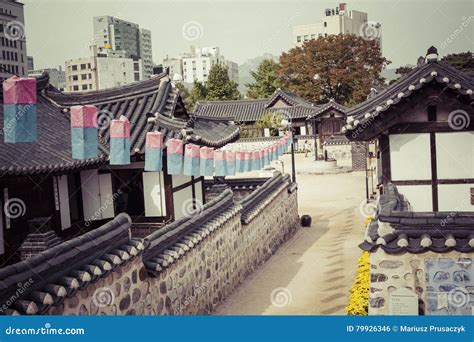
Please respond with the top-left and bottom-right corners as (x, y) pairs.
(369, 249), (474, 315)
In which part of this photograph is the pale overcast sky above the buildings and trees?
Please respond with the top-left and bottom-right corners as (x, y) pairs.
(22, 0), (474, 68)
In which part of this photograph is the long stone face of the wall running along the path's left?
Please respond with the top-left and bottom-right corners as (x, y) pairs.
(48, 186), (299, 315)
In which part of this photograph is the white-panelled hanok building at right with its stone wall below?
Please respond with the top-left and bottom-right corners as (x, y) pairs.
(343, 47), (474, 315)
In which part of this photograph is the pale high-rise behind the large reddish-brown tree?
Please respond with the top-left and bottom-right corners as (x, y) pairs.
(293, 3), (382, 46)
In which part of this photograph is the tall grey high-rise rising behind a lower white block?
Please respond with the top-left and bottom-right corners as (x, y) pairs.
(93, 15), (153, 79)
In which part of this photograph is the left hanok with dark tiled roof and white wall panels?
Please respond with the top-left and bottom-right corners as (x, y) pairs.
(0, 73), (239, 263)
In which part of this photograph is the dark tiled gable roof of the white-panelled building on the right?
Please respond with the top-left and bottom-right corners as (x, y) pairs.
(342, 51), (474, 140)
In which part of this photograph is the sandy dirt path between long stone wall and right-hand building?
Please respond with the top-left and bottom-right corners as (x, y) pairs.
(215, 172), (365, 315)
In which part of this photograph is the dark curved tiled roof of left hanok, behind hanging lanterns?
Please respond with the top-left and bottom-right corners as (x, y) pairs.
(0, 74), (239, 176)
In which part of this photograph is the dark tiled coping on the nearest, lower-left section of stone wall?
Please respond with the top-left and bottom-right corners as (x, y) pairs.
(0, 214), (145, 315)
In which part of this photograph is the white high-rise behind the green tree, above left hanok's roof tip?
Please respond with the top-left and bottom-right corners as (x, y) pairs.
(163, 46), (239, 83)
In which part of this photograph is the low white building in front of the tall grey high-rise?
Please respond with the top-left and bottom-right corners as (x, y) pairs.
(65, 46), (143, 92)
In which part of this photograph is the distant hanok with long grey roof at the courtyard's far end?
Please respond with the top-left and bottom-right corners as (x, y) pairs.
(195, 89), (368, 171)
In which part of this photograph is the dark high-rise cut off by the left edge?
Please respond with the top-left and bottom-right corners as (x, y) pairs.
(0, 0), (28, 81)
